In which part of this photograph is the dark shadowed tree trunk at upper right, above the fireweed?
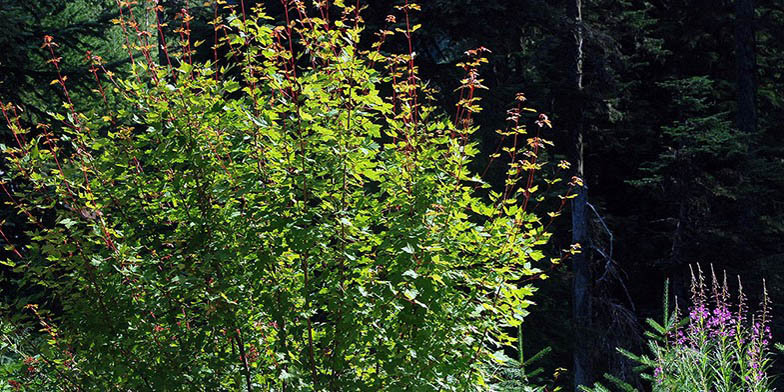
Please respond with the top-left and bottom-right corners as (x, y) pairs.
(735, 0), (757, 133)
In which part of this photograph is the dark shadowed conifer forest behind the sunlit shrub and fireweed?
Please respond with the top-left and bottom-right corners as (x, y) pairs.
(0, 0), (784, 388)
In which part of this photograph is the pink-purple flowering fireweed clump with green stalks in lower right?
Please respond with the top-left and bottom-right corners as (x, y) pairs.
(584, 266), (772, 392)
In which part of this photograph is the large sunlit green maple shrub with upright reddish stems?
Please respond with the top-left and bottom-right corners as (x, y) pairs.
(2, 1), (579, 391)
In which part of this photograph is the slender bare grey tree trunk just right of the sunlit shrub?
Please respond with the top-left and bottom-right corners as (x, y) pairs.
(567, 0), (592, 391)
